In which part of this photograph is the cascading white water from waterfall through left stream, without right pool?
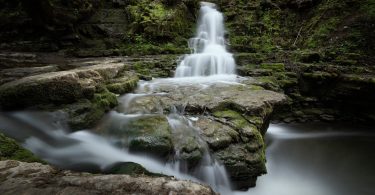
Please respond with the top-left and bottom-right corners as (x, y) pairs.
(0, 2), (238, 194)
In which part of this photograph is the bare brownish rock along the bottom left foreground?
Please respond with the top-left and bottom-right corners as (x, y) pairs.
(0, 161), (216, 195)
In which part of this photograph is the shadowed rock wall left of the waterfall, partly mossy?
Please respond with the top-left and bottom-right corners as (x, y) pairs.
(0, 0), (198, 57)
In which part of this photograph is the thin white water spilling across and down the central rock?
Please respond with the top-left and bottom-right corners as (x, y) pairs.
(106, 83), (238, 195)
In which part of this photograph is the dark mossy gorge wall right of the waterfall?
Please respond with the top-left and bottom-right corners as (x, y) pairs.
(213, 0), (375, 65)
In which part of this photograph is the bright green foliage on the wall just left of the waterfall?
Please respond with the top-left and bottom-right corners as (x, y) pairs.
(120, 0), (200, 55)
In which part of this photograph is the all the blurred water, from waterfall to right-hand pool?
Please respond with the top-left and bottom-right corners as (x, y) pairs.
(0, 3), (375, 195)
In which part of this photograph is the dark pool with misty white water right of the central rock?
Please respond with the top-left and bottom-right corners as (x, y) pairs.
(236, 123), (375, 195)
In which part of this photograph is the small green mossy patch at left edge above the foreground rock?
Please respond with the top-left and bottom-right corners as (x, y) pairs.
(0, 133), (45, 163)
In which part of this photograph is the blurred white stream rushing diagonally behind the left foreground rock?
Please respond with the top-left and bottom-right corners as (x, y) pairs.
(0, 112), (199, 181)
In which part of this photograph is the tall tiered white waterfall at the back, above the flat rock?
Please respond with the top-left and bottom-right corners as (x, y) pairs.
(175, 2), (236, 77)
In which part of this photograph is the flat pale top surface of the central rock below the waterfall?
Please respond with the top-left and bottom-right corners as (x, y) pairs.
(123, 77), (287, 115)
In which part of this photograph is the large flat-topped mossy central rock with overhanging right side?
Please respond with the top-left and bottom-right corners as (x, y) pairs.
(111, 79), (287, 189)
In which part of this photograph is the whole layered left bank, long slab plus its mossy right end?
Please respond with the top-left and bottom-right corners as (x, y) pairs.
(0, 52), (139, 129)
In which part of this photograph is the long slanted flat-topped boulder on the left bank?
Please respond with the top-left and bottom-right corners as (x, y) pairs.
(0, 63), (124, 109)
